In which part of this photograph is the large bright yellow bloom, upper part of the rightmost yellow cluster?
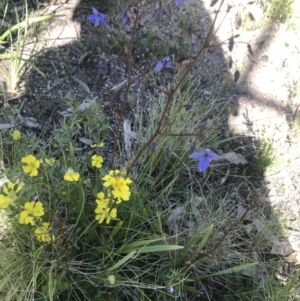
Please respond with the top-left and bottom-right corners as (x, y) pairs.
(102, 170), (132, 201)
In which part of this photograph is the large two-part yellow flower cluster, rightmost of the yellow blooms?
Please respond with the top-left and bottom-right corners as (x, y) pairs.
(95, 170), (132, 224)
